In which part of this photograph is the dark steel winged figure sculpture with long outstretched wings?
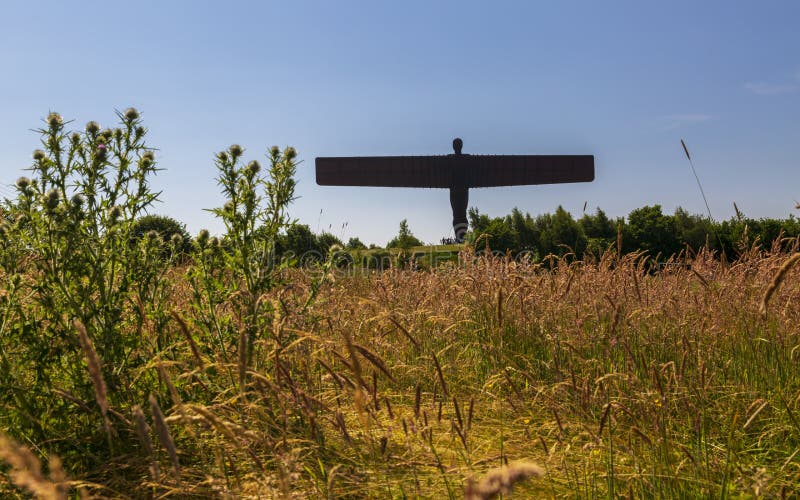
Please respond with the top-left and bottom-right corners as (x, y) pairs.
(316, 138), (594, 242)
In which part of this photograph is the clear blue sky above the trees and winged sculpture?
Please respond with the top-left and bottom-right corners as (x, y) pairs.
(0, 0), (800, 244)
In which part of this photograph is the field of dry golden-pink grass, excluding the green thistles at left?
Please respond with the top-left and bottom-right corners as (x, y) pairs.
(0, 245), (800, 498)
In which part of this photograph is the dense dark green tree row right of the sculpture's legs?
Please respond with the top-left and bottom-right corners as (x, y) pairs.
(468, 205), (800, 259)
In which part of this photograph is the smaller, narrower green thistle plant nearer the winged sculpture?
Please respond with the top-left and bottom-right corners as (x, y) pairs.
(189, 144), (297, 382)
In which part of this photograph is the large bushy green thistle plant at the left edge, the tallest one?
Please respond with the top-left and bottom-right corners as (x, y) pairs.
(0, 108), (167, 464)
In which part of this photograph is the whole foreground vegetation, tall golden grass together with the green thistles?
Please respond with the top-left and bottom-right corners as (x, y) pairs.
(0, 119), (800, 498)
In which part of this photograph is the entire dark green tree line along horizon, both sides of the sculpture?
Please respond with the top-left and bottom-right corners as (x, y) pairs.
(125, 205), (800, 267)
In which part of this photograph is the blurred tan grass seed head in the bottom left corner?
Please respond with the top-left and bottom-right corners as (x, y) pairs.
(0, 433), (69, 500)
